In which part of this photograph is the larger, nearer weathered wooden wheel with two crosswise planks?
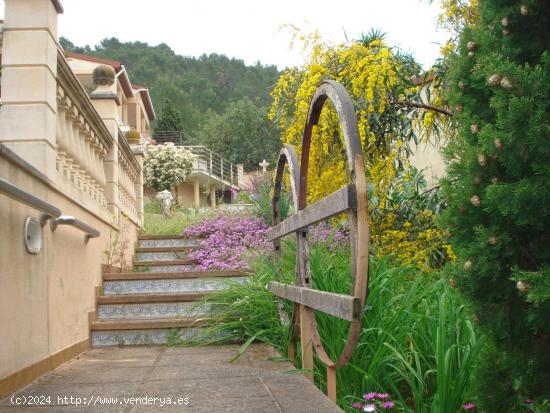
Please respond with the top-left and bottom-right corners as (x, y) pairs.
(268, 80), (369, 400)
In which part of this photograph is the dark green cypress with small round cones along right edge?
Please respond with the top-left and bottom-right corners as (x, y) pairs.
(442, 0), (550, 412)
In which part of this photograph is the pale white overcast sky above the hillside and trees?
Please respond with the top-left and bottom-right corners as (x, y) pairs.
(2, 0), (448, 69)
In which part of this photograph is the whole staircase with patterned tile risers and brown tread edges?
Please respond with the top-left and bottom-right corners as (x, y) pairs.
(90, 236), (246, 347)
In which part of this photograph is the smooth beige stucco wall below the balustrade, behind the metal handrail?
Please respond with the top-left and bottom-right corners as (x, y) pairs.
(0, 148), (137, 379)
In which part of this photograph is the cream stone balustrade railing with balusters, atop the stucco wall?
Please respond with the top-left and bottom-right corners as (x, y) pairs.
(56, 52), (142, 225)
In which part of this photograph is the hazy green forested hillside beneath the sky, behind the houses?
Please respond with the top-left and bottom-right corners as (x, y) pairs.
(59, 37), (279, 136)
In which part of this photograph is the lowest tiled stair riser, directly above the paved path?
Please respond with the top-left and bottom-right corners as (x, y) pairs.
(92, 328), (200, 347)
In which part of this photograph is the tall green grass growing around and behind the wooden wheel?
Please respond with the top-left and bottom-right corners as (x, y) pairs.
(184, 241), (479, 413)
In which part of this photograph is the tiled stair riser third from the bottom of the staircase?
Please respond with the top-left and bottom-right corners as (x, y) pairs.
(103, 277), (250, 295)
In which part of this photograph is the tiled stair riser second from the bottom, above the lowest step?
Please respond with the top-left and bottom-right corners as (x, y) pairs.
(97, 301), (210, 320)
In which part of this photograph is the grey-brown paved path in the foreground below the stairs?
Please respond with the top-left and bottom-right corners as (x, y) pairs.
(0, 344), (341, 413)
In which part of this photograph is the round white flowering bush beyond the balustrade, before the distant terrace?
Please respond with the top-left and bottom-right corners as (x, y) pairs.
(143, 143), (195, 191)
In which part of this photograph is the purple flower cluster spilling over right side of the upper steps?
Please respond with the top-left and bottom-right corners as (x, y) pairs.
(183, 214), (271, 270)
